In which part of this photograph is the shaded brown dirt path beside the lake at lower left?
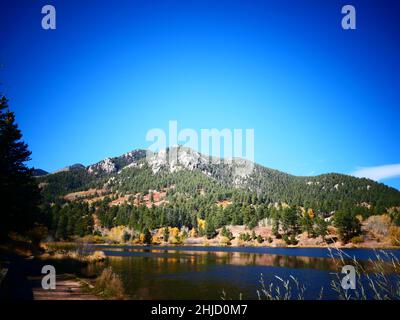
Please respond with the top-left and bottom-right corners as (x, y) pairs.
(29, 275), (100, 300)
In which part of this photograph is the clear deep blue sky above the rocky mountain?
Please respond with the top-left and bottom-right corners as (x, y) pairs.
(0, 0), (400, 188)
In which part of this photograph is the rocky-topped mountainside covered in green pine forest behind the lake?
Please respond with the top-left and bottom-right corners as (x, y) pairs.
(32, 147), (400, 243)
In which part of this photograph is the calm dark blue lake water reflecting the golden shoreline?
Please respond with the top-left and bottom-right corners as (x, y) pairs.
(89, 246), (400, 300)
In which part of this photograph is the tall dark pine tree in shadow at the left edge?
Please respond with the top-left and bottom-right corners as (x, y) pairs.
(0, 96), (39, 237)
